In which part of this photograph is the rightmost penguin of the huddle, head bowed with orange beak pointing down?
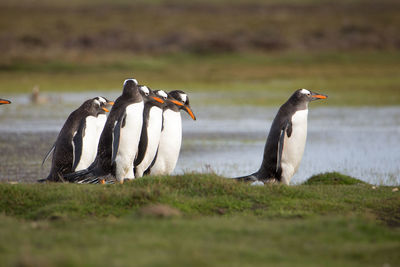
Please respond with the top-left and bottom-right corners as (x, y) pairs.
(145, 90), (196, 175)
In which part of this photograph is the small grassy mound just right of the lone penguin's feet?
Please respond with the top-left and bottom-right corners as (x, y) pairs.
(304, 172), (366, 185)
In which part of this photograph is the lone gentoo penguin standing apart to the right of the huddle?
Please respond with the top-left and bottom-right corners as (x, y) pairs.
(236, 89), (327, 185)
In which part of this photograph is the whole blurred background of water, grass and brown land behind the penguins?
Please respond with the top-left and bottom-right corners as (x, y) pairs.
(0, 0), (400, 184)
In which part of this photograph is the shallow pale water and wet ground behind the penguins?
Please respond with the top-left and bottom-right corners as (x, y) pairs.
(0, 92), (400, 185)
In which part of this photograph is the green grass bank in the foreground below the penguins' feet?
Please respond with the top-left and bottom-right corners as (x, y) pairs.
(0, 174), (400, 266)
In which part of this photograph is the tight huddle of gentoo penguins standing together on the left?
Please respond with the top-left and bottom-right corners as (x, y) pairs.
(39, 79), (196, 184)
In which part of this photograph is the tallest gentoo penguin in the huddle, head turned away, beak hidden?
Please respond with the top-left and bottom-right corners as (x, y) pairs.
(65, 79), (144, 183)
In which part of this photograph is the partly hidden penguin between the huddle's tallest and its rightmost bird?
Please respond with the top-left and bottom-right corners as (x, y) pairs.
(134, 86), (168, 177)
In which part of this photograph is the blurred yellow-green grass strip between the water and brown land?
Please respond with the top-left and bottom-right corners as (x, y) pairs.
(0, 52), (400, 105)
